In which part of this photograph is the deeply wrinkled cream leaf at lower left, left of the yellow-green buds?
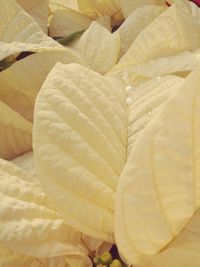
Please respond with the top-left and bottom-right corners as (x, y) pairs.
(0, 160), (85, 258)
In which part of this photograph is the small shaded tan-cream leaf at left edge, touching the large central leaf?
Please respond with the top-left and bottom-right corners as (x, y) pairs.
(0, 101), (32, 159)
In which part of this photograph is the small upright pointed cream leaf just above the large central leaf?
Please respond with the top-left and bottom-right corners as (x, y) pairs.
(76, 22), (120, 74)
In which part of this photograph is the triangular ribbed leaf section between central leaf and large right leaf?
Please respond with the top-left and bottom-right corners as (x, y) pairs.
(126, 76), (184, 155)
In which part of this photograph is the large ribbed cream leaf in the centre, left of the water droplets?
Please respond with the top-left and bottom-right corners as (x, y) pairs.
(33, 64), (127, 241)
